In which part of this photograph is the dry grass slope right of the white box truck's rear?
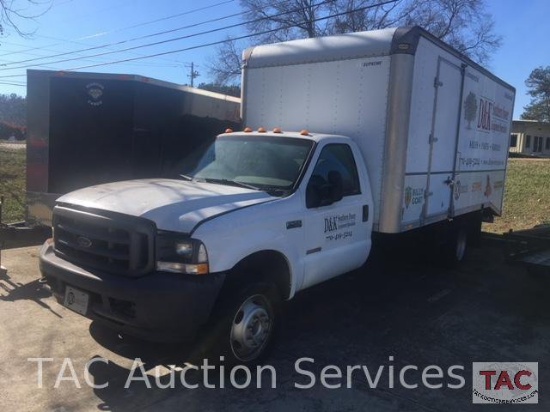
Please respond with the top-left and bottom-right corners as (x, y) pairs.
(483, 159), (550, 233)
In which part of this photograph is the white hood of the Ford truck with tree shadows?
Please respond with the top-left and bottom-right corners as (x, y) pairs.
(57, 179), (276, 233)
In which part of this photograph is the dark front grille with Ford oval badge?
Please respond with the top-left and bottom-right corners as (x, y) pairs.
(53, 206), (155, 276)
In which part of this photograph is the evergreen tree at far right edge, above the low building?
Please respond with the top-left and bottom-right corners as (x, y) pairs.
(521, 66), (550, 123)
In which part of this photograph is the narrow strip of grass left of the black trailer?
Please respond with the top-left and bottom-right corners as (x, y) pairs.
(0, 143), (26, 223)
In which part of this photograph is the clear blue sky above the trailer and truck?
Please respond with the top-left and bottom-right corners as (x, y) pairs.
(0, 0), (550, 119)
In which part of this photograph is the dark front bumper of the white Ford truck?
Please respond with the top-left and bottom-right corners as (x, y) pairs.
(40, 240), (225, 342)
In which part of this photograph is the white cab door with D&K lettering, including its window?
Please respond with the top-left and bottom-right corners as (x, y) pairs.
(302, 143), (370, 288)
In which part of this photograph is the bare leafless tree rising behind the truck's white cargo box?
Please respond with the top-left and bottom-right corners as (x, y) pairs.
(210, 0), (501, 83)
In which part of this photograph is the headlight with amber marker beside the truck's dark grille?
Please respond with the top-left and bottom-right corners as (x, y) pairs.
(156, 231), (209, 275)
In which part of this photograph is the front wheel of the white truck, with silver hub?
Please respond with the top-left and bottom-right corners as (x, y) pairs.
(210, 283), (281, 364)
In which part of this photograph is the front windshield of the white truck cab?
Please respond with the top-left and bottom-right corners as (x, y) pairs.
(180, 135), (313, 192)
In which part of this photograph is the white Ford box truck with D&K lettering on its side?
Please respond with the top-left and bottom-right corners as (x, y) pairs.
(40, 27), (515, 362)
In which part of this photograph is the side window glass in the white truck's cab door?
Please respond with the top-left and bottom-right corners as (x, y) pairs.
(306, 144), (361, 208)
